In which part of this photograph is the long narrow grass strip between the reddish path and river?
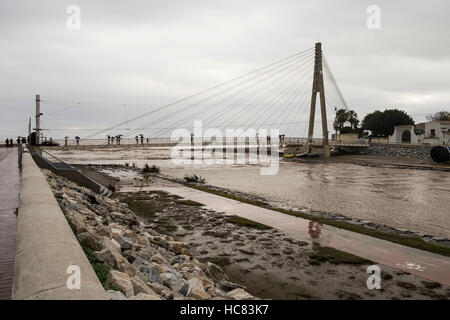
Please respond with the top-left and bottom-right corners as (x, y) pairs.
(185, 184), (450, 257)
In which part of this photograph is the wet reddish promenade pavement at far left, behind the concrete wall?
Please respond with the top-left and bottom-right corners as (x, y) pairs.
(0, 148), (20, 300)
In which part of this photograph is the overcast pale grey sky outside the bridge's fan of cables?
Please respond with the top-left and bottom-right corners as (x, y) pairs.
(0, 0), (450, 139)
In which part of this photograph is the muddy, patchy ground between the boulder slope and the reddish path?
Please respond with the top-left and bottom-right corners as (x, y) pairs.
(106, 170), (450, 299)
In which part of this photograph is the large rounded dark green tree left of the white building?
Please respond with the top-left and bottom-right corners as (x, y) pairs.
(362, 109), (414, 137)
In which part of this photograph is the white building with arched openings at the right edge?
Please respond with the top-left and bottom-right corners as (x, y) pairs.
(389, 120), (450, 145)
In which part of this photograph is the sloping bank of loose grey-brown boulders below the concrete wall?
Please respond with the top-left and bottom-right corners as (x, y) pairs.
(45, 171), (255, 300)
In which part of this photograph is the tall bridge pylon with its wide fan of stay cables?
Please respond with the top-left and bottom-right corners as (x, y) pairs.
(32, 43), (366, 156)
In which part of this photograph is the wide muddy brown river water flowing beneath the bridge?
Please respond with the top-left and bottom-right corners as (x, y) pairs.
(46, 149), (450, 238)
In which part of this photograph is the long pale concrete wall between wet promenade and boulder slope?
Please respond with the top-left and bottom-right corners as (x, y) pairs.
(12, 153), (108, 300)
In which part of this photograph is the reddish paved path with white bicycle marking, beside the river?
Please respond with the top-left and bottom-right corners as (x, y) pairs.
(124, 186), (450, 286)
